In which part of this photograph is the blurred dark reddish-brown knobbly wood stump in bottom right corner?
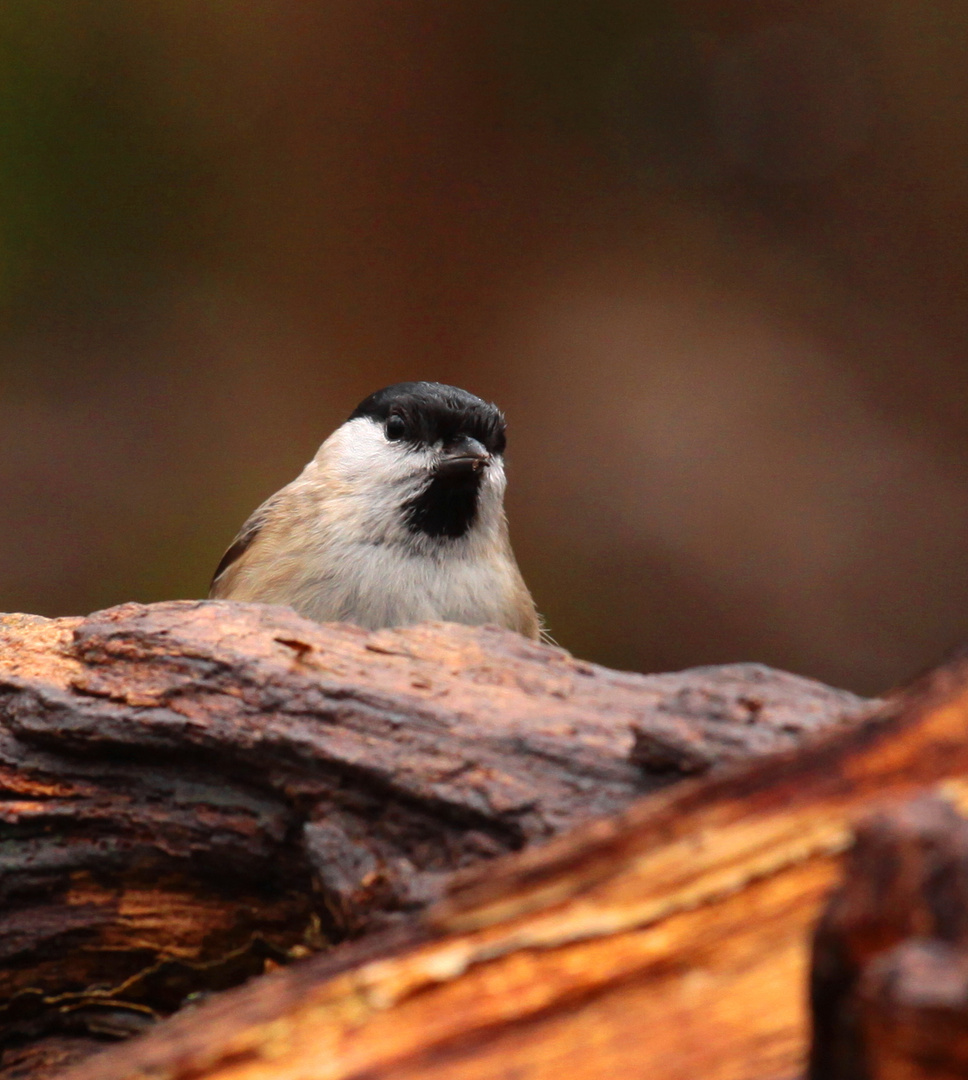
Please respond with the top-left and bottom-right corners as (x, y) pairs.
(810, 798), (968, 1080)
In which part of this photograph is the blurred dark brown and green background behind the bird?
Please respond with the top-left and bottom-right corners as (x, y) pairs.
(0, 0), (968, 692)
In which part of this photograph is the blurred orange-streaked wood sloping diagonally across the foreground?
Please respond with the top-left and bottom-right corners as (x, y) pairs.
(45, 648), (968, 1080)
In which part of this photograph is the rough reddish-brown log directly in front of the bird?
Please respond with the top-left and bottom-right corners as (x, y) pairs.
(0, 602), (863, 1077)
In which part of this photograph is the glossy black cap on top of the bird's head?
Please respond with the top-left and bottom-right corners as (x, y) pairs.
(349, 382), (506, 454)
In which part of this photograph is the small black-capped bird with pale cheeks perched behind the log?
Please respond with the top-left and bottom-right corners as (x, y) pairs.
(209, 382), (541, 638)
